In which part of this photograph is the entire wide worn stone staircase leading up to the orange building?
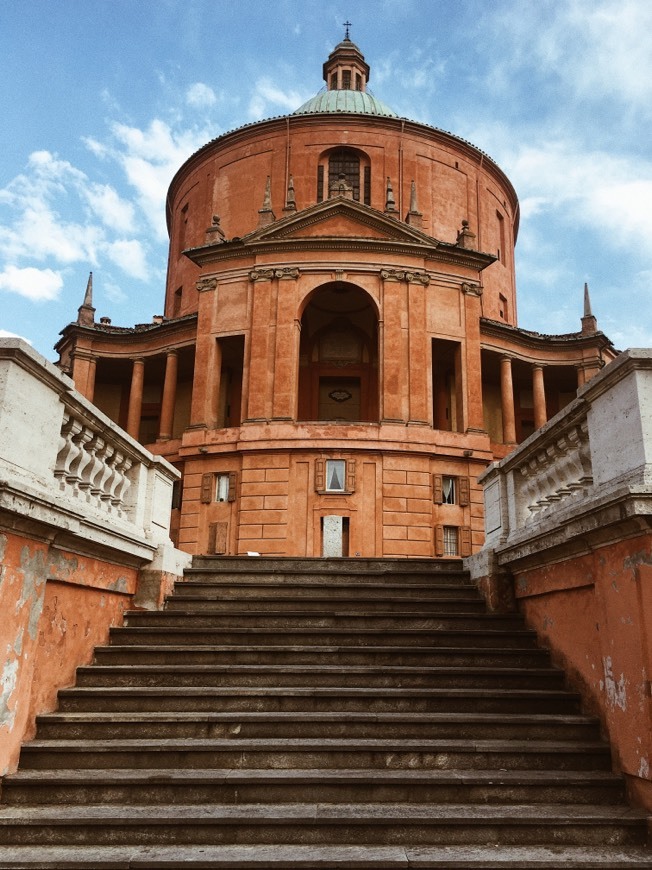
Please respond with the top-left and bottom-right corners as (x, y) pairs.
(0, 558), (652, 870)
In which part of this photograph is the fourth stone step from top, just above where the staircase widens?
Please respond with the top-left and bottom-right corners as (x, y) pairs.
(165, 592), (486, 615)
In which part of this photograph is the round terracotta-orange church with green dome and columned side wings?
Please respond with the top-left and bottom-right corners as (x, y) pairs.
(57, 36), (615, 557)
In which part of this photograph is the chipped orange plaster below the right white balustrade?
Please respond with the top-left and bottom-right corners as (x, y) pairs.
(514, 535), (652, 809)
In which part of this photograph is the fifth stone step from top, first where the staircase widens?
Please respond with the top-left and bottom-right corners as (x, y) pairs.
(125, 608), (523, 634)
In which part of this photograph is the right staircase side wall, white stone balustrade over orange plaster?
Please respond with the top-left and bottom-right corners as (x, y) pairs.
(468, 350), (652, 810)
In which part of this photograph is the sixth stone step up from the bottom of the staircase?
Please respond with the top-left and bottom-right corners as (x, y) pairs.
(53, 686), (579, 714)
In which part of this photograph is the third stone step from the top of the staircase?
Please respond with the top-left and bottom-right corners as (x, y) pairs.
(171, 575), (482, 604)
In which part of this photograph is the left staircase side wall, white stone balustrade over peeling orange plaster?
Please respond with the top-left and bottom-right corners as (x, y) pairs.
(0, 339), (188, 774)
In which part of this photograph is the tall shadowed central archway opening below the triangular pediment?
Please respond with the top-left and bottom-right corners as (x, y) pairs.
(298, 281), (379, 423)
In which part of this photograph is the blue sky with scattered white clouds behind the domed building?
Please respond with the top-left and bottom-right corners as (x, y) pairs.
(0, 0), (652, 359)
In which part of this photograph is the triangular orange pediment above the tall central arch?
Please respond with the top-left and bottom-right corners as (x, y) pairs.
(243, 197), (438, 247)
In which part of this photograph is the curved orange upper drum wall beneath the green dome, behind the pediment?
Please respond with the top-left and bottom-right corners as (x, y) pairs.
(165, 114), (518, 325)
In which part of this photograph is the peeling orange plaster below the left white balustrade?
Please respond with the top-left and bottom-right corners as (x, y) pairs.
(0, 533), (137, 774)
